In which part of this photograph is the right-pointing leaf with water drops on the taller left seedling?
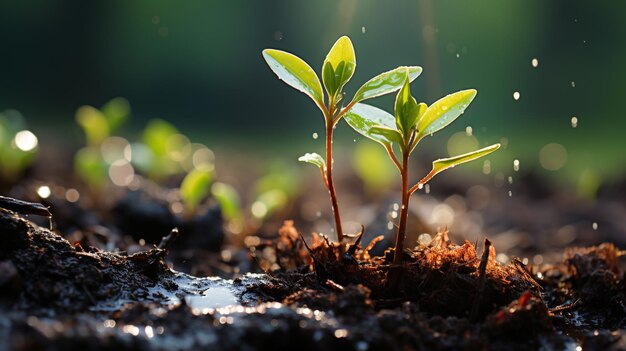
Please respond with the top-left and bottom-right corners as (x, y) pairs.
(352, 66), (422, 102)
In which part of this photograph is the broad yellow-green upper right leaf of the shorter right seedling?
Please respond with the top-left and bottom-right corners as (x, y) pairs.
(417, 89), (476, 139)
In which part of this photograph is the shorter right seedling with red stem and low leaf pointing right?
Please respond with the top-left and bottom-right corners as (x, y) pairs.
(345, 71), (500, 265)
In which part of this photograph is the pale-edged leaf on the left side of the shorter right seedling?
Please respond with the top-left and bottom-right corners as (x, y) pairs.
(344, 103), (400, 145)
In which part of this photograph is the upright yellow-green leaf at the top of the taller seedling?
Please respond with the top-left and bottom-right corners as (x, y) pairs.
(322, 36), (356, 98)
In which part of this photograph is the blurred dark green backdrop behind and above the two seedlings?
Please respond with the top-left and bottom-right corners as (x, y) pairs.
(0, 0), (626, 190)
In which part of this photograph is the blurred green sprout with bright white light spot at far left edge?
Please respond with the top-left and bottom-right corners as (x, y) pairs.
(0, 110), (39, 182)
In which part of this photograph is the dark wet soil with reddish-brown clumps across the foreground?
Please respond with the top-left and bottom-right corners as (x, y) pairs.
(0, 209), (626, 351)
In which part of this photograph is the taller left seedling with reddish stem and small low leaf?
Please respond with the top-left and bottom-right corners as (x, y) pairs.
(263, 36), (422, 250)
